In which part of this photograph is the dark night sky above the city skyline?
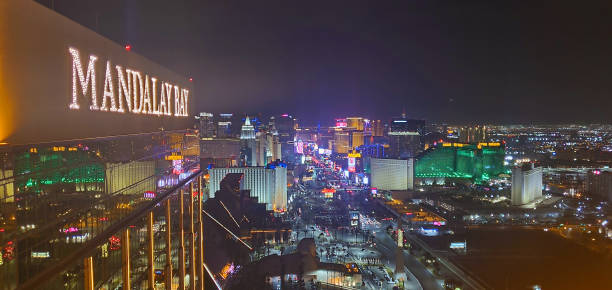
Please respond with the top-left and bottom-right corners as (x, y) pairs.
(39, 0), (612, 124)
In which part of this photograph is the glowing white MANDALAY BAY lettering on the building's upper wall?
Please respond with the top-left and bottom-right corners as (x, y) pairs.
(68, 47), (189, 117)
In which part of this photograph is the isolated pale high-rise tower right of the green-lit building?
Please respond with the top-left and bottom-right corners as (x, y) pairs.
(511, 163), (542, 205)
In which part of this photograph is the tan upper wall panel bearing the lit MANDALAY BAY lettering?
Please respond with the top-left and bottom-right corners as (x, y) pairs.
(0, 0), (194, 145)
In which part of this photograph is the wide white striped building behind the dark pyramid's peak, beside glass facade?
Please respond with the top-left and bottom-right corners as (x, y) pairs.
(209, 164), (287, 210)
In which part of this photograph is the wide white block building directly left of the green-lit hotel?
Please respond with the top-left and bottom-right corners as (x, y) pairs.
(370, 158), (414, 190)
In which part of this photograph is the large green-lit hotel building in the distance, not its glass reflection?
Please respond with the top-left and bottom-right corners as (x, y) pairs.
(414, 143), (509, 183)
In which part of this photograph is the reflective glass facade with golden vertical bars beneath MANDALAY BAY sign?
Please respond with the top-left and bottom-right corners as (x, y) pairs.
(0, 131), (206, 289)
